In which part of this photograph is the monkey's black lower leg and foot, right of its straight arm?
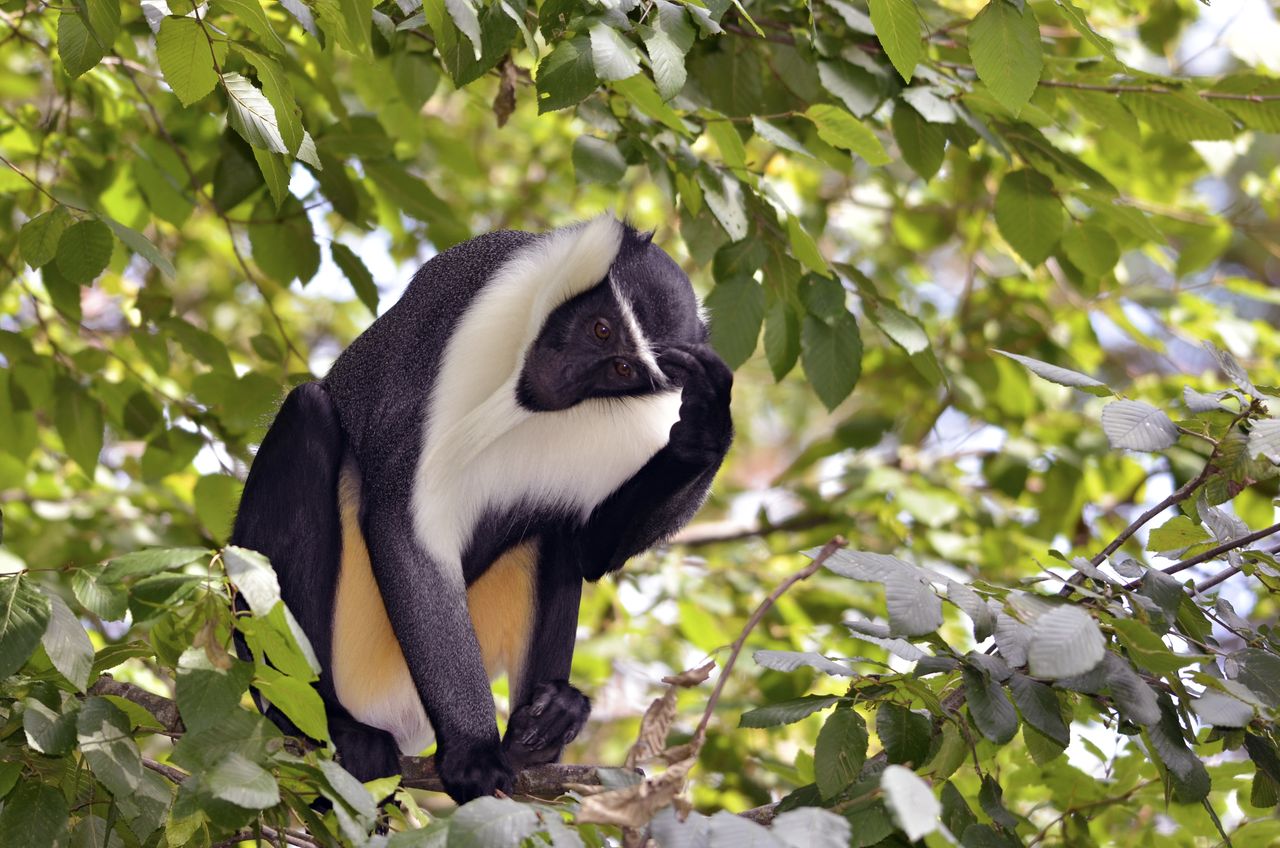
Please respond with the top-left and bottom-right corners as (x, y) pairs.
(502, 545), (591, 770)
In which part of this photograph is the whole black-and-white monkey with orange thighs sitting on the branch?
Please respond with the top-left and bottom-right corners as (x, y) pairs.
(233, 216), (733, 803)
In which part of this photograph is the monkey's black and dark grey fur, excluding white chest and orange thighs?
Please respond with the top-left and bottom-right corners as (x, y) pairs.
(233, 222), (732, 802)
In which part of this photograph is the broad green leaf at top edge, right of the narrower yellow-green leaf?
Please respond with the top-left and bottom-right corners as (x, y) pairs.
(969, 0), (1044, 117)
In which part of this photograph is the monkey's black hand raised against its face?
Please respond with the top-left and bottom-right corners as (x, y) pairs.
(659, 345), (733, 468)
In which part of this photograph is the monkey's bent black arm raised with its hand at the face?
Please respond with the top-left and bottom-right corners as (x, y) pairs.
(575, 345), (733, 580)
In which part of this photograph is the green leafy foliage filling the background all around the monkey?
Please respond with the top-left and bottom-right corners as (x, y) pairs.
(0, 0), (1280, 847)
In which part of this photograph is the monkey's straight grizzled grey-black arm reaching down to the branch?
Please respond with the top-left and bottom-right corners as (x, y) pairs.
(362, 489), (515, 803)
